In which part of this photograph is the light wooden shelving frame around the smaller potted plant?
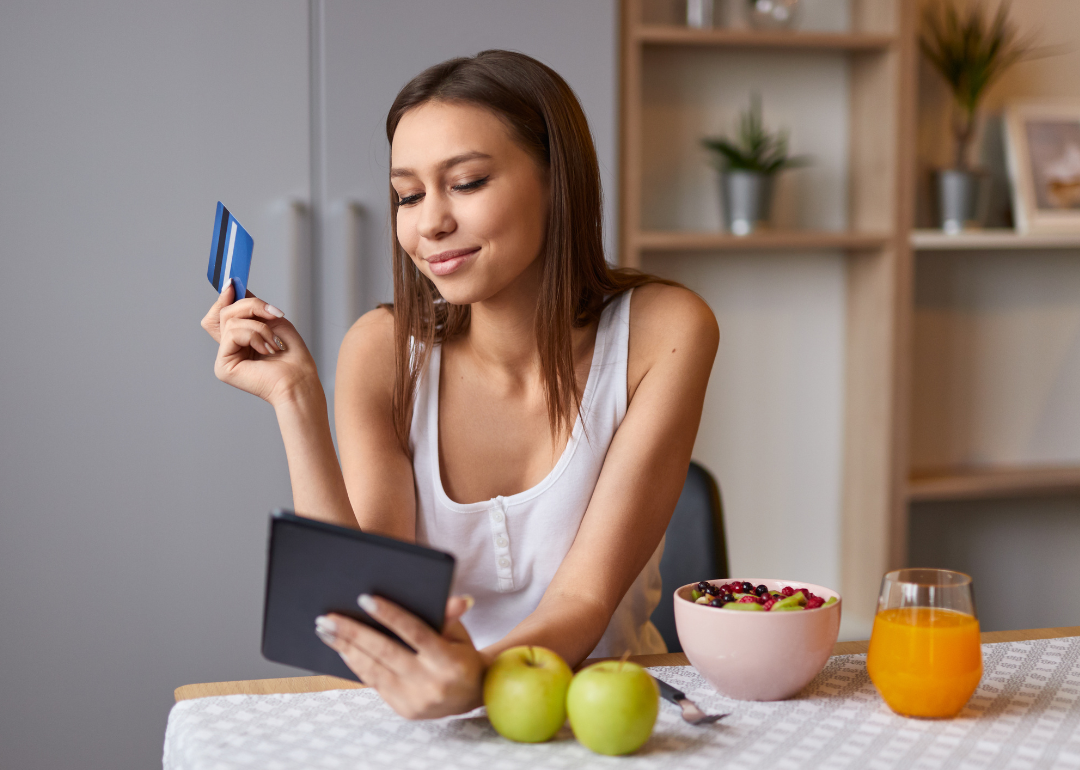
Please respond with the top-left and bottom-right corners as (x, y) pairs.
(619, 0), (917, 631)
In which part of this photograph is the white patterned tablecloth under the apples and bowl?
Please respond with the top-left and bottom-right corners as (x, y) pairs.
(164, 637), (1080, 770)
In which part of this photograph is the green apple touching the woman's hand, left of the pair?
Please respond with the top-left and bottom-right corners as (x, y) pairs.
(484, 647), (573, 743)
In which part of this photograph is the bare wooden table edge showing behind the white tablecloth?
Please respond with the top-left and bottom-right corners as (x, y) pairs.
(173, 625), (1080, 701)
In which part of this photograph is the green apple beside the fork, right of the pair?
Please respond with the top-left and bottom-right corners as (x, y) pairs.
(566, 661), (660, 755)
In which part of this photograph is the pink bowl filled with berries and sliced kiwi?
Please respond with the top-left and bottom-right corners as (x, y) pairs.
(675, 580), (840, 701)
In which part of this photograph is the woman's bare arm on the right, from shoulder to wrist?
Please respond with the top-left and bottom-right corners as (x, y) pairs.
(483, 284), (719, 666)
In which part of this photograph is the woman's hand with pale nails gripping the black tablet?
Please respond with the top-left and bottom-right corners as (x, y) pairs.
(315, 594), (486, 719)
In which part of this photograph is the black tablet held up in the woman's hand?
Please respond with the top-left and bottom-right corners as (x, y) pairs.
(262, 511), (454, 680)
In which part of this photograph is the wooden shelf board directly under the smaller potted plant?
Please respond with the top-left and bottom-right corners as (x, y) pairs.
(631, 230), (889, 252)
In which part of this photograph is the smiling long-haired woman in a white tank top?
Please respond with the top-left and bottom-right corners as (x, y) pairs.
(203, 51), (718, 718)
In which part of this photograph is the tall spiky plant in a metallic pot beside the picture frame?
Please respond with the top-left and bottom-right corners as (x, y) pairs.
(919, 0), (1029, 233)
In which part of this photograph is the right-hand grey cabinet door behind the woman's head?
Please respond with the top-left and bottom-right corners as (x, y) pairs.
(313, 0), (618, 388)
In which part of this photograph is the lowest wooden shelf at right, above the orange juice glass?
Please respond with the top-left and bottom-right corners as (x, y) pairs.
(907, 465), (1080, 502)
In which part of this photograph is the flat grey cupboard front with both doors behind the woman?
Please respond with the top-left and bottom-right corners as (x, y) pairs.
(0, 0), (616, 770)
